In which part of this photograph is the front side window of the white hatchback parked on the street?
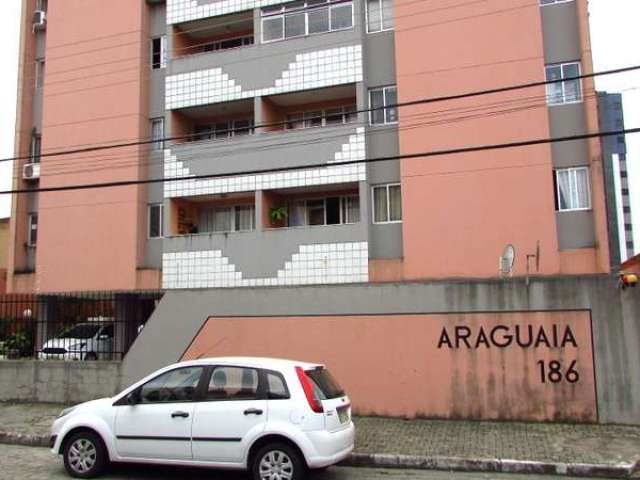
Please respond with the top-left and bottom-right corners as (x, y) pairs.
(140, 367), (204, 403)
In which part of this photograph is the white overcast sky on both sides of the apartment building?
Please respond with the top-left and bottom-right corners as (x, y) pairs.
(0, 0), (640, 253)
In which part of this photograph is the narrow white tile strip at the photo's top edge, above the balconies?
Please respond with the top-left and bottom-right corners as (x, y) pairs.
(167, 0), (291, 25)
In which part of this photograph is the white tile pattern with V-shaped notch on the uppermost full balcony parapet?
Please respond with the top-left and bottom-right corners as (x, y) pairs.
(165, 45), (362, 110)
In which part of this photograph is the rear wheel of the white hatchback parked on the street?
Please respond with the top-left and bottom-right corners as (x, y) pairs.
(251, 443), (307, 480)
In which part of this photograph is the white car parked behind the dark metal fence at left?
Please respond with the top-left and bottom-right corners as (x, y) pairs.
(38, 321), (114, 360)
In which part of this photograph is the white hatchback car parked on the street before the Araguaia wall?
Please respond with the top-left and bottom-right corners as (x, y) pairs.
(51, 357), (355, 480)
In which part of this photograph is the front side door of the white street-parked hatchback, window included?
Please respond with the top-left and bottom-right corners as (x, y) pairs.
(114, 366), (205, 460)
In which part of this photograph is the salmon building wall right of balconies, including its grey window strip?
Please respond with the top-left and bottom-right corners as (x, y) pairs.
(395, 0), (608, 279)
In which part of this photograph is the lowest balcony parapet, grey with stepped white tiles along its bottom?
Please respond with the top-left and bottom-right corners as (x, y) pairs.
(162, 223), (368, 289)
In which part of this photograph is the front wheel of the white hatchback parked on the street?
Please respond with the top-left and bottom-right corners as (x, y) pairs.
(63, 432), (108, 478)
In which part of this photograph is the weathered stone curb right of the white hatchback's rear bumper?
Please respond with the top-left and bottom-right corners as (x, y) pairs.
(341, 453), (640, 478)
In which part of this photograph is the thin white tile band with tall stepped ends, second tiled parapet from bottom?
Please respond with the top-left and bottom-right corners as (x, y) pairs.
(164, 127), (366, 198)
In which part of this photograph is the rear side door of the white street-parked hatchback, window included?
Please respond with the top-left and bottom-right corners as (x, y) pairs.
(192, 365), (267, 464)
